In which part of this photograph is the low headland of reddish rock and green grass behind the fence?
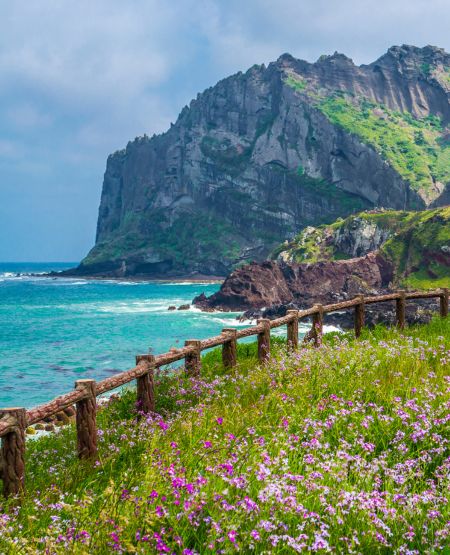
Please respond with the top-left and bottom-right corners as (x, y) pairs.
(194, 207), (450, 314)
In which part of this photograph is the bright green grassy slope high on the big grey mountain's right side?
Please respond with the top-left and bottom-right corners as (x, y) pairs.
(285, 74), (450, 202)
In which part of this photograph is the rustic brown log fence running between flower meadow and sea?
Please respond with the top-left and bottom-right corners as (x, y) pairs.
(0, 289), (449, 496)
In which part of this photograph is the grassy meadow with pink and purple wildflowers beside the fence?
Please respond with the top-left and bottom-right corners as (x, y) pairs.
(0, 318), (450, 555)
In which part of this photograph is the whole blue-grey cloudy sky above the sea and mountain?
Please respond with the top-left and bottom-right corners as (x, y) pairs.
(0, 0), (450, 261)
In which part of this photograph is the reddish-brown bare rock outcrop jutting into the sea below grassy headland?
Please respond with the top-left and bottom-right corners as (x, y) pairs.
(193, 253), (393, 310)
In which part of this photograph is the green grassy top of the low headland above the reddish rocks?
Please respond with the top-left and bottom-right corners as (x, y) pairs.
(272, 207), (450, 288)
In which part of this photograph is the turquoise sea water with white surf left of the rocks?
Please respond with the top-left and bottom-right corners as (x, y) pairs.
(0, 263), (310, 408)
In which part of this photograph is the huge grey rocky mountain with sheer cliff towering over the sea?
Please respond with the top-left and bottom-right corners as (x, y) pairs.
(78, 46), (450, 276)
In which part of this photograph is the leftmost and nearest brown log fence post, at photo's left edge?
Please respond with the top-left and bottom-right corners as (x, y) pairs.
(0, 408), (26, 497)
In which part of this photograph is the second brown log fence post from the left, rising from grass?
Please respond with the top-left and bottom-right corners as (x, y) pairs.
(75, 380), (97, 459)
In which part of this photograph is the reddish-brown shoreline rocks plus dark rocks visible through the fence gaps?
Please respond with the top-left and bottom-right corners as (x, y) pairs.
(193, 252), (436, 329)
